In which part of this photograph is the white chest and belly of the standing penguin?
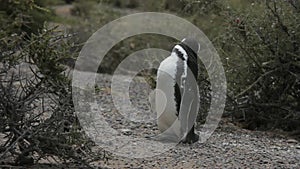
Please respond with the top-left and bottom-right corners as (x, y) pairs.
(155, 53), (179, 132)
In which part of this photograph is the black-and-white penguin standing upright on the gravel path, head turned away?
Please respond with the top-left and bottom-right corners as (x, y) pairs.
(155, 38), (200, 144)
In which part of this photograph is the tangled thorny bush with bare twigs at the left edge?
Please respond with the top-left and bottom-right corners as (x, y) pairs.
(0, 0), (96, 165)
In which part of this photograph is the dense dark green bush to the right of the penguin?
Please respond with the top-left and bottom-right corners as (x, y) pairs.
(219, 1), (300, 131)
